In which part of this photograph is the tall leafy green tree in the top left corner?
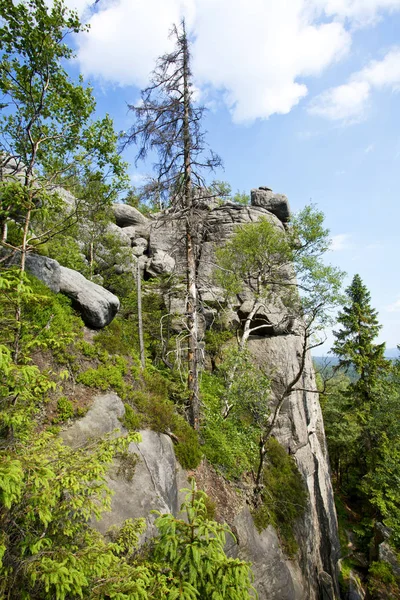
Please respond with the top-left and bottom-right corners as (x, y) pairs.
(0, 0), (125, 270)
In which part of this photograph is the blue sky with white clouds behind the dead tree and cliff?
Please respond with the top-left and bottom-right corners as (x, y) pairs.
(64, 0), (400, 354)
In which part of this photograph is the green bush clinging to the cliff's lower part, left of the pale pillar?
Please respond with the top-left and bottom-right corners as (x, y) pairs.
(253, 438), (307, 556)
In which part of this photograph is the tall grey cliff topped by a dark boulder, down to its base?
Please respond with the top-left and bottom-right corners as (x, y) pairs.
(104, 189), (339, 600)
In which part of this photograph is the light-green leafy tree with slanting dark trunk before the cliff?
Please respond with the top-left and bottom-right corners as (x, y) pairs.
(216, 207), (343, 489)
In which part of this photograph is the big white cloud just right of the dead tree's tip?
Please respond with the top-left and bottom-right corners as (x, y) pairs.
(194, 0), (350, 122)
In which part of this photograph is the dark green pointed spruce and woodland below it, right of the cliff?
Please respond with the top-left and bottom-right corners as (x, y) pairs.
(324, 275), (400, 547)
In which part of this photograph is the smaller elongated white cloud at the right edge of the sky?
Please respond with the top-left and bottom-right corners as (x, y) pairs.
(308, 47), (400, 123)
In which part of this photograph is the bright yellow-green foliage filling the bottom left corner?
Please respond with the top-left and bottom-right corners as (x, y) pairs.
(0, 426), (141, 600)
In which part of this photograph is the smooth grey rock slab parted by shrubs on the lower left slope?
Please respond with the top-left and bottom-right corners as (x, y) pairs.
(61, 393), (190, 539)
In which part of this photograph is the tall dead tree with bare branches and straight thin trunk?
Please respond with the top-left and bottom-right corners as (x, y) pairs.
(125, 21), (221, 430)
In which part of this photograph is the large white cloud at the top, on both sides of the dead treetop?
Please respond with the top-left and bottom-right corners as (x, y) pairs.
(69, 0), (351, 122)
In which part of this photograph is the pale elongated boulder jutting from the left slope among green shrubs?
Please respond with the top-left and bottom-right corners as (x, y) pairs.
(60, 267), (119, 329)
